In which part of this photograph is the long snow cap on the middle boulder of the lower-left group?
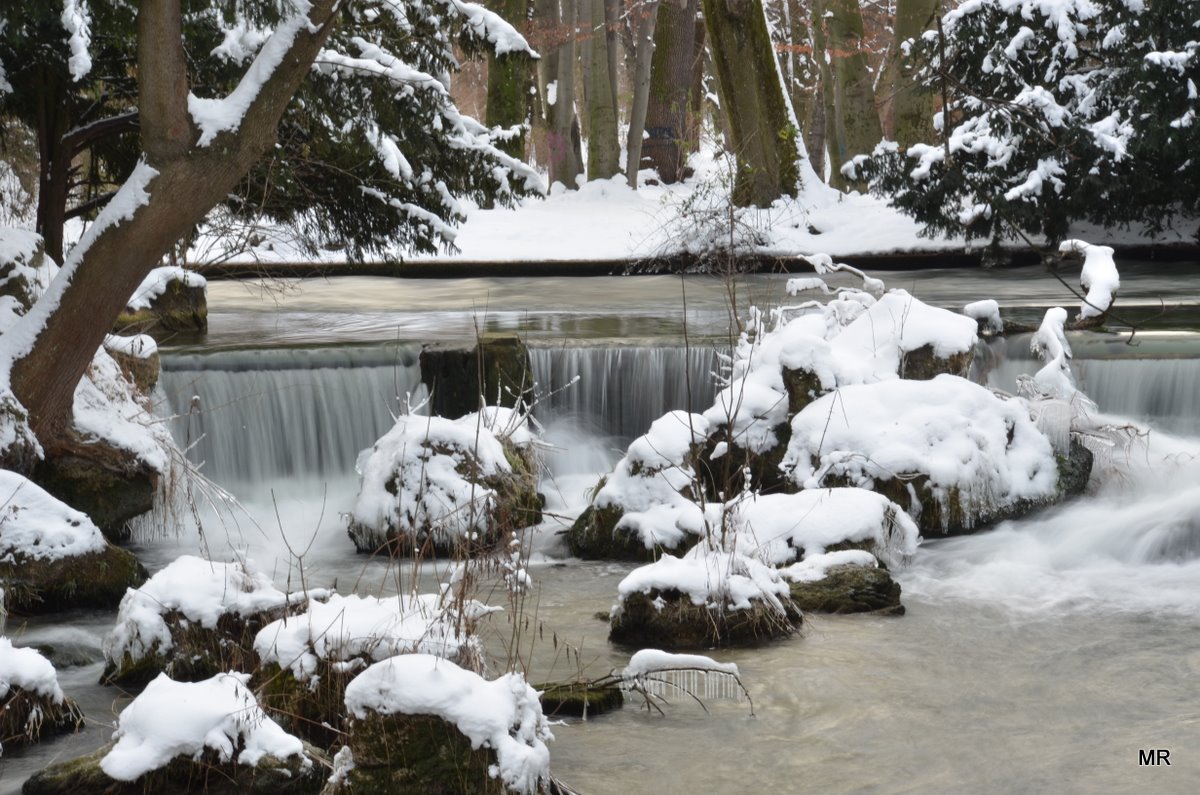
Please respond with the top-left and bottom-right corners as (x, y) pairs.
(254, 594), (494, 681)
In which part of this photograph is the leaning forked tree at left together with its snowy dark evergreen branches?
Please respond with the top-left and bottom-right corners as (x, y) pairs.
(0, 0), (536, 452)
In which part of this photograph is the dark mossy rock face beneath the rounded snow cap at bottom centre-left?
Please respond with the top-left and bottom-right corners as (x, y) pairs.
(325, 712), (505, 795)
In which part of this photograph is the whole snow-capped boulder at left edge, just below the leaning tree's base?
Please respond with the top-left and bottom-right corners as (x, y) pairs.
(0, 470), (146, 614)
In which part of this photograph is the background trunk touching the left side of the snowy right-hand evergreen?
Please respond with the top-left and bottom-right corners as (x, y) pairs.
(882, 0), (941, 149)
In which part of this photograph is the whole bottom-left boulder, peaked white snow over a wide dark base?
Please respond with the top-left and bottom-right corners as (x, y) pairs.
(24, 673), (316, 795)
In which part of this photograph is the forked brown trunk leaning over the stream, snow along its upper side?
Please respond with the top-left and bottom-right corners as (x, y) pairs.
(8, 0), (338, 452)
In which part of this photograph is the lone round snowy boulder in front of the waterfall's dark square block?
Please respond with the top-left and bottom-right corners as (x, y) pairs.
(347, 407), (541, 555)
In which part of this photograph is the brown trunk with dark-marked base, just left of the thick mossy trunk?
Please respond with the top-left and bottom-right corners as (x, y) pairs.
(642, 0), (700, 184)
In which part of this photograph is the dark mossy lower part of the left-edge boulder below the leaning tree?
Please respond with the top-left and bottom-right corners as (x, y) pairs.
(0, 544), (148, 615)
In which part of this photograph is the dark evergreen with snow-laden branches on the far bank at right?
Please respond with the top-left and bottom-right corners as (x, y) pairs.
(857, 0), (1200, 244)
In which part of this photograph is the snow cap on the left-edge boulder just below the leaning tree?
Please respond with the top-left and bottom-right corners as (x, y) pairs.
(0, 470), (106, 561)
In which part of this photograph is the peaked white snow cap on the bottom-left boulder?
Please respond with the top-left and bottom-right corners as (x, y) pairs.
(100, 674), (312, 782)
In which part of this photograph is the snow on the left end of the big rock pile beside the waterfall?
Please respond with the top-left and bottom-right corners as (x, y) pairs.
(592, 411), (709, 549)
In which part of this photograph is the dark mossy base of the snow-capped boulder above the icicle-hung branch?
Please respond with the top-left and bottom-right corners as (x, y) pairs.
(608, 590), (803, 651)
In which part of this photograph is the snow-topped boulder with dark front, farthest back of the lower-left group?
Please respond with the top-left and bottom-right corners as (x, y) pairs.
(102, 555), (305, 685)
